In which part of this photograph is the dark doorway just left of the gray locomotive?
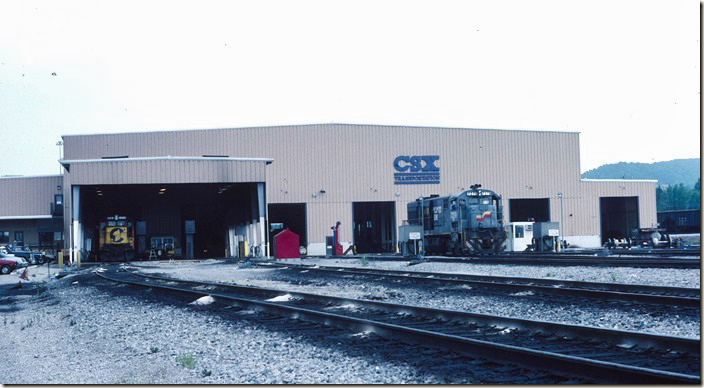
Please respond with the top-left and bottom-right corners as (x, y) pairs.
(352, 202), (396, 253)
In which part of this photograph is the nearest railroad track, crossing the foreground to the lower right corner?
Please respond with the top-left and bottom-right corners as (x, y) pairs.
(96, 272), (701, 384)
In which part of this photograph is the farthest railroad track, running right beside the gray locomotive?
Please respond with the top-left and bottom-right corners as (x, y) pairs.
(307, 254), (701, 268)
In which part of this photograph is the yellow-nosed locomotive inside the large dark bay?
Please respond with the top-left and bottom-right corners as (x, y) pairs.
(98, 215), (134, 261)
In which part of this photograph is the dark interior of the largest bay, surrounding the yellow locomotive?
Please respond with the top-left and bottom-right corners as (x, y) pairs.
(80, 183), (252, 260)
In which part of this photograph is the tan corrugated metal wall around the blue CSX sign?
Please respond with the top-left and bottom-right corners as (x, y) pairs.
(64, 124), (655, 242)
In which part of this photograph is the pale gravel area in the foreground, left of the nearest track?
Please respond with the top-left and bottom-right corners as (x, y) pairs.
(0, 281), (470, 384)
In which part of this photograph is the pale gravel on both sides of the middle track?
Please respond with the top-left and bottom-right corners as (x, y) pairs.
(133, 259), (700, 337)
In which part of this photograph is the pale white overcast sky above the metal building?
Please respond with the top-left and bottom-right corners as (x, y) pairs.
(0, 0), (701, 175)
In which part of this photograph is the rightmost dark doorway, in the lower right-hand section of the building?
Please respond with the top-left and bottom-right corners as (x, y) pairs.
(599, 197), (640, 244)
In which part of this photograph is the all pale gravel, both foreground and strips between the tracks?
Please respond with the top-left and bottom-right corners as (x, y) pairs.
(0, 259), (700, 384)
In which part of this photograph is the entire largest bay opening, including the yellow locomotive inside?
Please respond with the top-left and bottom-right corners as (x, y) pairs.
(80, 183), (257, 261)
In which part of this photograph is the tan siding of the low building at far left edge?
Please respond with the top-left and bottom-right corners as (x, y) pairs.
(0, 175), (62, 217)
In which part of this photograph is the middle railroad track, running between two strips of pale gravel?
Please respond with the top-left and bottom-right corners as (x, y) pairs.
(258, 263), (701, 307)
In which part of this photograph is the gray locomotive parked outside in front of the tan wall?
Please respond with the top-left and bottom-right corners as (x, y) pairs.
(408, 185), (506, 256)
